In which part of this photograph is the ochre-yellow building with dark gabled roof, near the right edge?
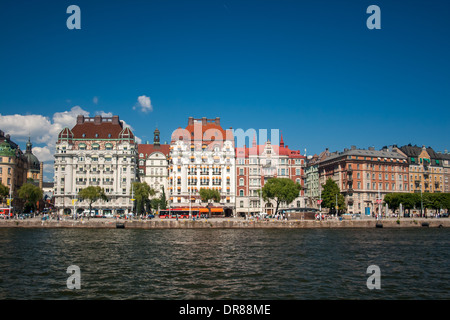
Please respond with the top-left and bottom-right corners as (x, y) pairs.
(394, 144), (444, 193)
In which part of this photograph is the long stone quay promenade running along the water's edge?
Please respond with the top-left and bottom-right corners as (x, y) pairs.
(0, 218), (450, 229)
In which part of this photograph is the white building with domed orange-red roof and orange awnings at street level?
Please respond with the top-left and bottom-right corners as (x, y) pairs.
(168, 117), (236, 216)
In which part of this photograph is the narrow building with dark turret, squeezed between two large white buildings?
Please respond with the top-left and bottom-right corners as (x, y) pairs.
(138, 129), (170, 198)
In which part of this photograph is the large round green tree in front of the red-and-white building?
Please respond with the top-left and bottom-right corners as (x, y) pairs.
(260, 178), (302, 213)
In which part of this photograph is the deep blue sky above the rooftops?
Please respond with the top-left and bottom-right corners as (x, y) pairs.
(0, 0), (450, 178)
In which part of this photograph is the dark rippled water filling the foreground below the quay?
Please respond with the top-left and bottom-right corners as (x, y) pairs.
(0, 228), (450, 300)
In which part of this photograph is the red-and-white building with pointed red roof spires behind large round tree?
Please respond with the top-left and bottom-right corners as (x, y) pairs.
(236, 135), (306, 216)
